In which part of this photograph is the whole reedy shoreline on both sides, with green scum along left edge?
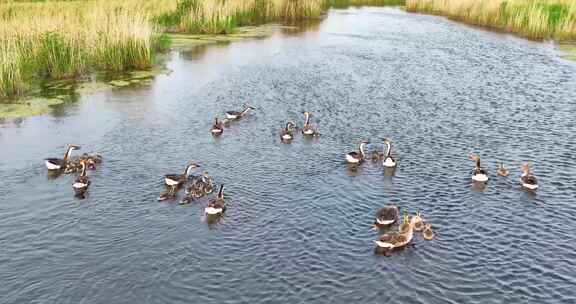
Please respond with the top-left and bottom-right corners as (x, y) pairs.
(0, 0), (576, 117)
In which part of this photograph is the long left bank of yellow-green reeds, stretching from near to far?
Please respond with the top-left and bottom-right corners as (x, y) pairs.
(0, 0), (403, 102)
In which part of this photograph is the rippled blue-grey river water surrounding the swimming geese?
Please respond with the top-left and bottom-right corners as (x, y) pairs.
(0, 8), (576, 304)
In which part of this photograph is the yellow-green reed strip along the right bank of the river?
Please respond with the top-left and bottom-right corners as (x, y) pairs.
(406, 0), (576, 40)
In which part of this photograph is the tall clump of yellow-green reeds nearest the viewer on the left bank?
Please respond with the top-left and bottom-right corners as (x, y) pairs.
(0, 0), (175, 98)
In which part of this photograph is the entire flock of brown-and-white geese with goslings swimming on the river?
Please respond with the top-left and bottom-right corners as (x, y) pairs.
(45, 106), (538, 255)
